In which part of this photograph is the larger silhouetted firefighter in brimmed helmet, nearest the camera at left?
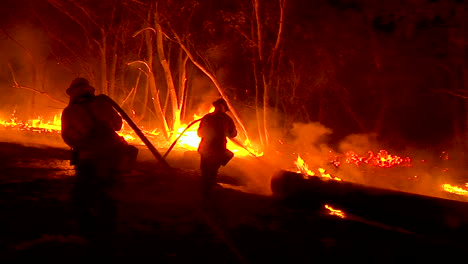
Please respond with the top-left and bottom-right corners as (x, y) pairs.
(62, 78), (138, 245)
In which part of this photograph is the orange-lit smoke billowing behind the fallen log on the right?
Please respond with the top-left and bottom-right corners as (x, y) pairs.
(227, 114), (468, 201)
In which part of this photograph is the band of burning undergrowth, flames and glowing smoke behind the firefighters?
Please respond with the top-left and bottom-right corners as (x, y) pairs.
(0, 109), (468, 201)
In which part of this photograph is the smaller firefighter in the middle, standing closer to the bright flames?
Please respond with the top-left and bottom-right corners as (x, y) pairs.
(197, 99), (237, 198)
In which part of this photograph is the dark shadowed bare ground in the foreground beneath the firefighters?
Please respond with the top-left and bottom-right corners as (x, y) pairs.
(0, 139), (468, 263)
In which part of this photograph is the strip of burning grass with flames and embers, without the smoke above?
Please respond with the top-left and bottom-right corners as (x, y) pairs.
(0, 110), (468, 201)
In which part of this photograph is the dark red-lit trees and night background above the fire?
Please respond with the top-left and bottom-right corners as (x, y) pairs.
(1, 0), (468, 152)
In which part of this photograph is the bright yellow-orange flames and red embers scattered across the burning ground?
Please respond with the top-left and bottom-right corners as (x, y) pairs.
(4, 108), (468, 203)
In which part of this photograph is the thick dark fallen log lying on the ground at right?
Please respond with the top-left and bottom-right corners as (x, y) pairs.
(271, 171), (468, 243)
